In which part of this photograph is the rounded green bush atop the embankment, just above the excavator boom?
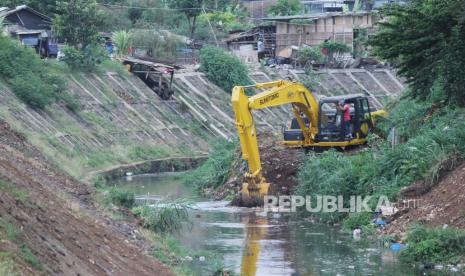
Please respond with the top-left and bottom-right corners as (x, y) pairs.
(200, 46), (251, 93)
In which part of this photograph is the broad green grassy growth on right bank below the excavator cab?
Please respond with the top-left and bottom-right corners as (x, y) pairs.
(297, 96), (465, 221)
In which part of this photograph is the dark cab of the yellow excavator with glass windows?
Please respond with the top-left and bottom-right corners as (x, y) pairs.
(283, 94), (373, 145)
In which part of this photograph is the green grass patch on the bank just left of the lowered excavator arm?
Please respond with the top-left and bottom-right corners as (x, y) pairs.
(182, 140), (237, 191)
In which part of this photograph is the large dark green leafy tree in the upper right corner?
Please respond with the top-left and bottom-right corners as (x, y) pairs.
(369, 0), (465, 105)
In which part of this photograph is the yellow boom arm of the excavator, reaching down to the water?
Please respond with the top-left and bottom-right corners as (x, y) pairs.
(231, 80), (318, 199)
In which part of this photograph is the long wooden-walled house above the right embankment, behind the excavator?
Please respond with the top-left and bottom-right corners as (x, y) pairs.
(263, 12), (375, 53)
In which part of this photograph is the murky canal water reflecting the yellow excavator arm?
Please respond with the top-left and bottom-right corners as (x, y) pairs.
(116, 175), (416, 276)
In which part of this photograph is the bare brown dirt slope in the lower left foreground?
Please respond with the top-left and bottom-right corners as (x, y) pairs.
(0, 123), (172, 275)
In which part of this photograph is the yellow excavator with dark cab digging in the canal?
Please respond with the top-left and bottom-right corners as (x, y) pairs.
(231, 80), (387, 205)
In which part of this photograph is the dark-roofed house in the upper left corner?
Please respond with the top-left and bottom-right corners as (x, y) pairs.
(0, 5), (58, 56)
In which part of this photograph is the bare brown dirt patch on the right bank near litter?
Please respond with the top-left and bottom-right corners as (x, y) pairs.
(388, 162), (465, 233)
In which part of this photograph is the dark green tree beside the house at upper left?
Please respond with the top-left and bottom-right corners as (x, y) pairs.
(54, 0), (102, 48)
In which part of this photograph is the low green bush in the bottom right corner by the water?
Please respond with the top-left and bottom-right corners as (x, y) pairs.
(400, 225), (465, 264)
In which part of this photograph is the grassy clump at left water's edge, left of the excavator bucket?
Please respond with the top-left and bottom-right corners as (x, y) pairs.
(133, 201), (189, 233)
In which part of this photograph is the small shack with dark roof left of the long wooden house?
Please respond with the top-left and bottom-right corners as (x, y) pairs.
(225, 25), (276, 63)
